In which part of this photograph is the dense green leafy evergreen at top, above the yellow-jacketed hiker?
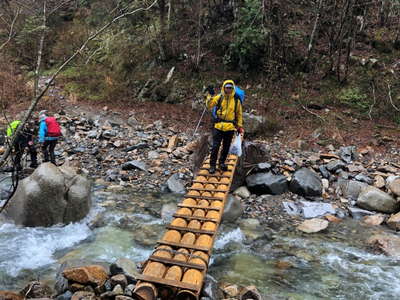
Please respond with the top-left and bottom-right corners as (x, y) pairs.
(224, 0), (268, 71)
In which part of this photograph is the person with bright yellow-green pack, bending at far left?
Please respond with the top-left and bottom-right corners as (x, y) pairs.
(7, 120), (38, 171)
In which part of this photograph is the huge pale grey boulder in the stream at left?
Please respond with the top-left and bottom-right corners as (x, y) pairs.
(5, 163), (91, 227)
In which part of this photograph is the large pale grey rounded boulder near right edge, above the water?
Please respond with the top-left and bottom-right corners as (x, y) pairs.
(357, 186), (400, 213)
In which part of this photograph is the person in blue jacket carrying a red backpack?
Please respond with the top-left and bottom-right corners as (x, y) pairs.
(39, 110), (61, 164)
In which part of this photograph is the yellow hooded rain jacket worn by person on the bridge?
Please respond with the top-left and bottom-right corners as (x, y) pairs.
(206, 80), (243, 131)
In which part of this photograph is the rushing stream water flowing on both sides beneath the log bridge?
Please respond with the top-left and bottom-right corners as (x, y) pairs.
(0, 186), (400, 300)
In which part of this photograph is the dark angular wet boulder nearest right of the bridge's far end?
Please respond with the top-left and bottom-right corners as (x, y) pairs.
(246, 172), (288, 195)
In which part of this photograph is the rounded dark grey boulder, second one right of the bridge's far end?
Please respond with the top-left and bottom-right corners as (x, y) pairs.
(289, 168), (322, 197)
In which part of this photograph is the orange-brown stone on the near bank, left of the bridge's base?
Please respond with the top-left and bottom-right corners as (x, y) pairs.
(62, 265), (108, 286)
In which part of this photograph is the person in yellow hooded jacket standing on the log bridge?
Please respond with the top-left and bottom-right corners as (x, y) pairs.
(206, 80), (244, 174)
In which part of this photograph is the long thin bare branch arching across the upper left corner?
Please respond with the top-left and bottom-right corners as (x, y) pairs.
(0, 0), (158, 167)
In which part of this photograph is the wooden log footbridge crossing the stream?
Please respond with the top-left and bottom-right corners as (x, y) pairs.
(133, 155), (237, 300)
